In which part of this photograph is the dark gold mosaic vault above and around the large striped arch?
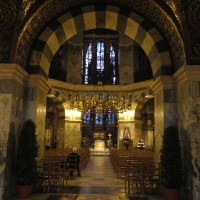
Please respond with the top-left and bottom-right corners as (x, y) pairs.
(0, 0), (200, 69)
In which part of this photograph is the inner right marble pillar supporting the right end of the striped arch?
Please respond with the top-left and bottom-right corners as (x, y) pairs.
(152, 76), (178, 161)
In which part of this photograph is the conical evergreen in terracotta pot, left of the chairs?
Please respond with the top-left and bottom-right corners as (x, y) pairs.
(15, 119), (38, 199)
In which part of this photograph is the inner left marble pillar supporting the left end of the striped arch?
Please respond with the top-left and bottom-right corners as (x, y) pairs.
(24, 75), (50, 160)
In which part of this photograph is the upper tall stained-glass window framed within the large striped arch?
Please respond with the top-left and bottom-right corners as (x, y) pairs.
(82, 29), (119, 85)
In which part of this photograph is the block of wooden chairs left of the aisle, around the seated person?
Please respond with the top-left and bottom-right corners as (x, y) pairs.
(37, 148), (90, 192)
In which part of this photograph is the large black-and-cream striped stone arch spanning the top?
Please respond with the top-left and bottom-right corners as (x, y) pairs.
(29, 6), (174, 79)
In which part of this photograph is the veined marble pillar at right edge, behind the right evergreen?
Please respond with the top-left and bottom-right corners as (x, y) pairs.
(174, 65), (200, 200)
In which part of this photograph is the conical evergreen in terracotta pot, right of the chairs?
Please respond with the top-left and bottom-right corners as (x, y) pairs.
(160, 125), (183, 200)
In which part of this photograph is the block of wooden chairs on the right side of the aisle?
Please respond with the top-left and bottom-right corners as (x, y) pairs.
(111, 149), (161, 194)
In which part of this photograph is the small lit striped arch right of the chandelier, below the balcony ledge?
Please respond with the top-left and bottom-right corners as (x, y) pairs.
(134, 90), (153, 120)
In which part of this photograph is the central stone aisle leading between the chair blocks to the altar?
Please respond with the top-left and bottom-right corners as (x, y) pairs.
(47, 155), (129, 200)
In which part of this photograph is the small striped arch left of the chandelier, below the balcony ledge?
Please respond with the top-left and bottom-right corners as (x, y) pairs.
(47, 89), (66, 119)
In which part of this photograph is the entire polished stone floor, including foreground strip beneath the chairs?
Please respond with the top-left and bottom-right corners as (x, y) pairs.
(9, 155), (164, 200)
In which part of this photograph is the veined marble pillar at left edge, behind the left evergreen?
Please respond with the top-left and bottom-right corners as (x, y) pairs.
(0, 63), (28, 199)
